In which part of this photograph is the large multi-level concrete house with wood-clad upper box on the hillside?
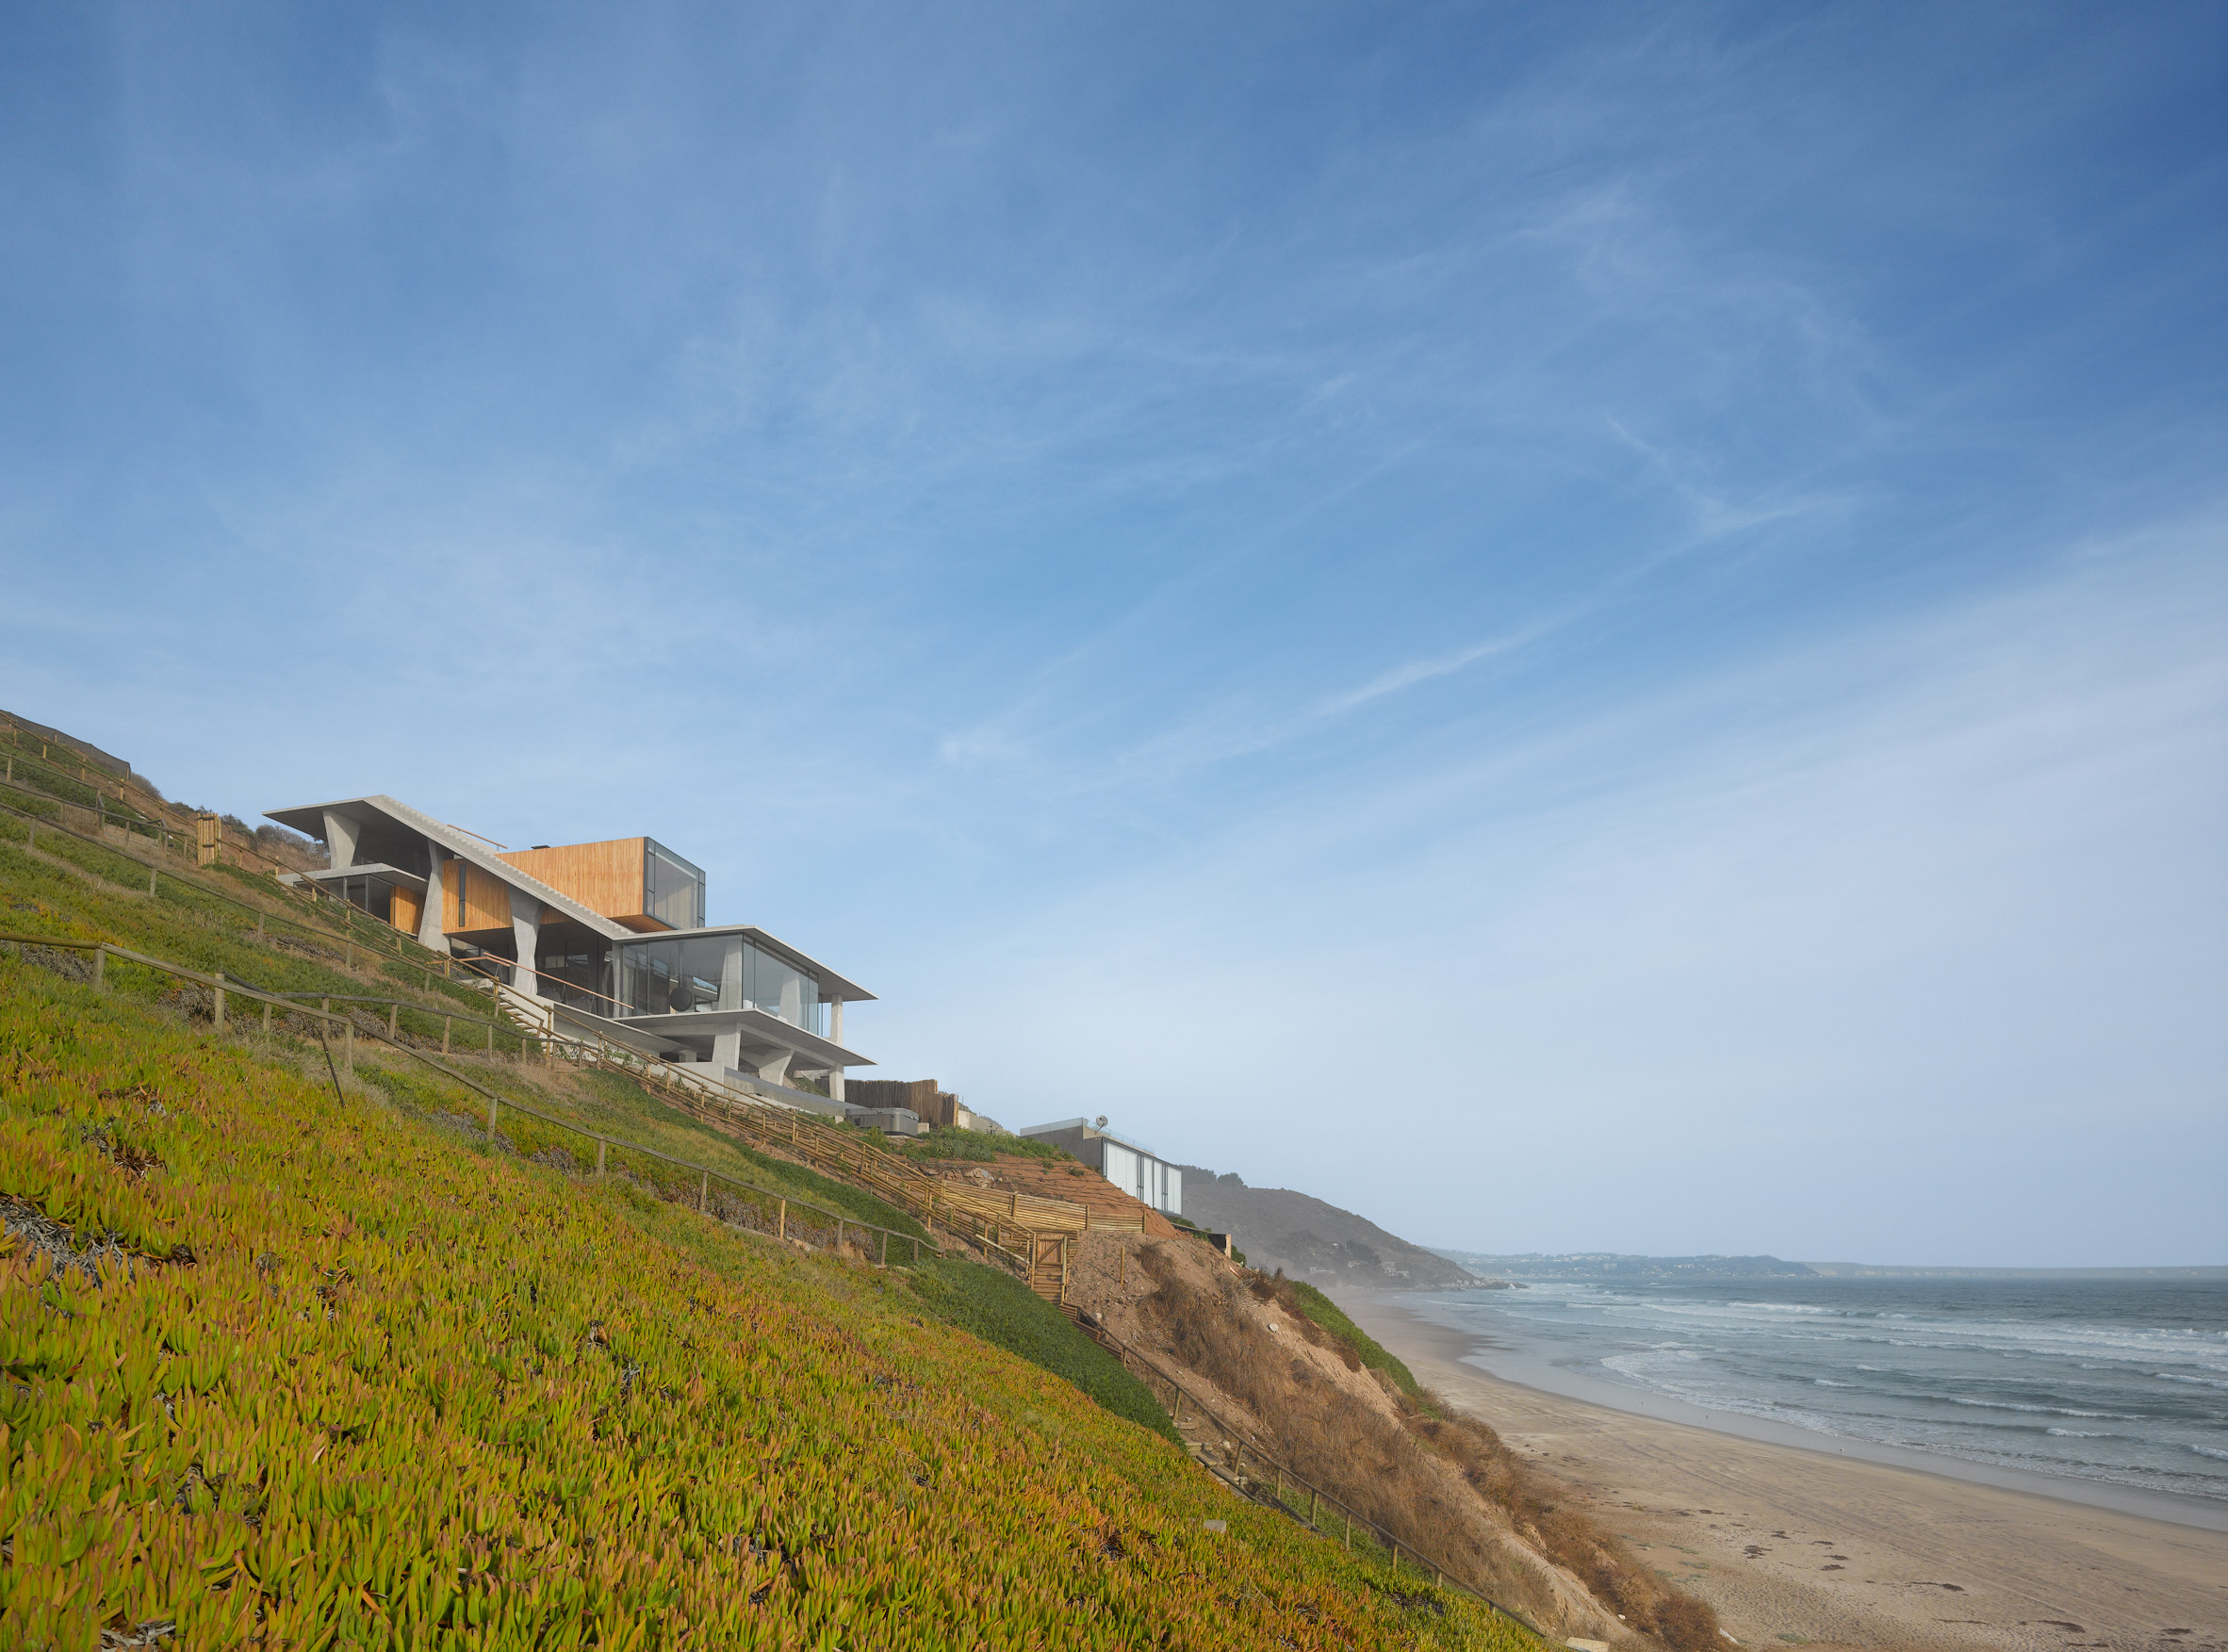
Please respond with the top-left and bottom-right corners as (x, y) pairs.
(270, 794), (880, 1122)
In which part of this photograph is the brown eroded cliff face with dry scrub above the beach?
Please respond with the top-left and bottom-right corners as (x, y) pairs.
(1067, 1231), (1640, 1644)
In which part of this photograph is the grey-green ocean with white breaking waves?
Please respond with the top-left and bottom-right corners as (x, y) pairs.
(1415, 1278), (2228, 1500)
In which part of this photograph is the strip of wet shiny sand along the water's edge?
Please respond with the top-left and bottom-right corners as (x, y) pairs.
(1377, 1291), (2228, 1531)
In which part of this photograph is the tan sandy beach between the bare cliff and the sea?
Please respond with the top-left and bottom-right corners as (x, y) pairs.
(1339, 1291), (2228, 1650)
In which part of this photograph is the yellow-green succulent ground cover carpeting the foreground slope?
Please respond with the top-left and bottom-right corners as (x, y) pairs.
(0, 842), (1535, 1647)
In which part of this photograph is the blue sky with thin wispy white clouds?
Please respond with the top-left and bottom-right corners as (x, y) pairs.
(0, 5), (2228, 1265)
